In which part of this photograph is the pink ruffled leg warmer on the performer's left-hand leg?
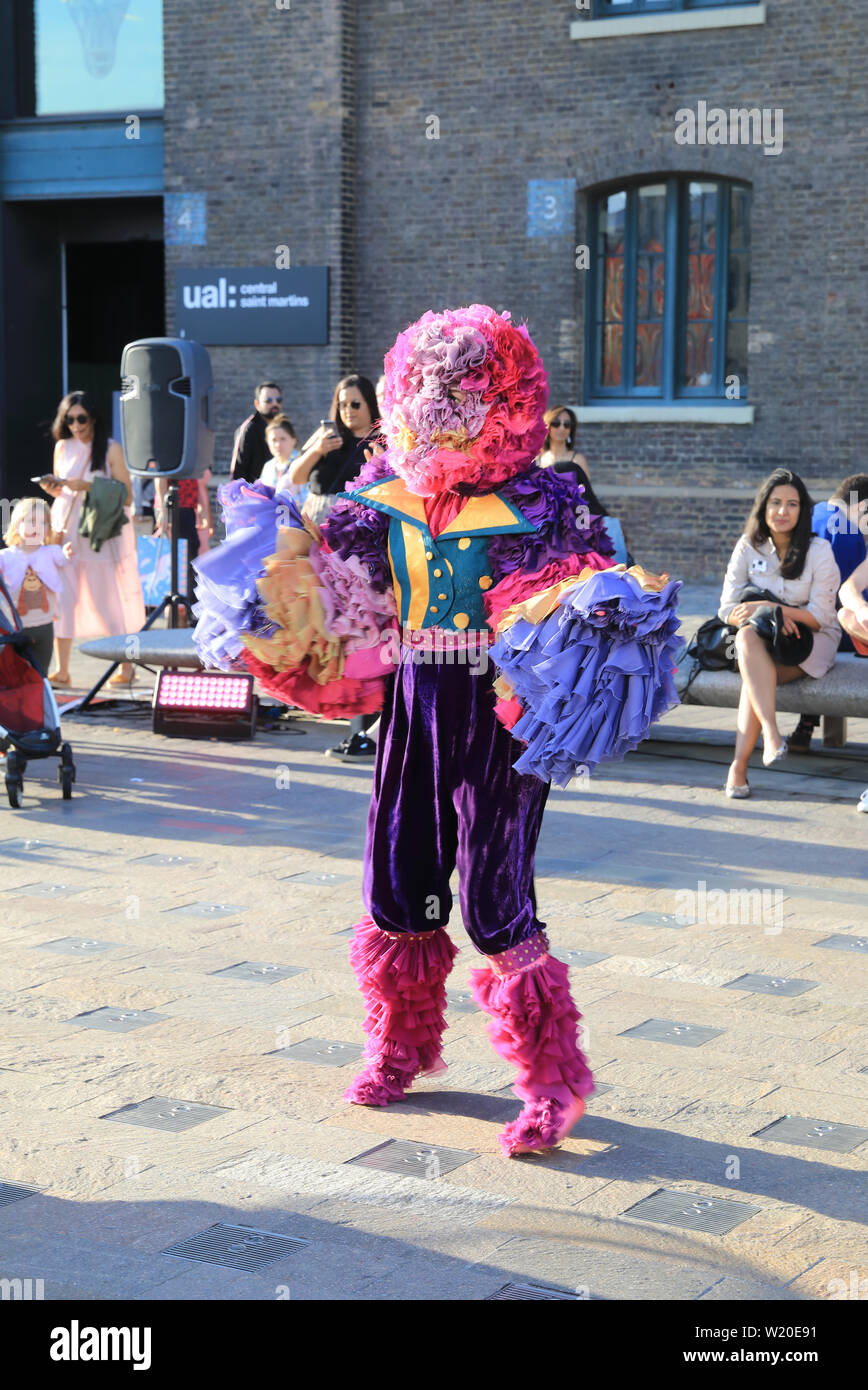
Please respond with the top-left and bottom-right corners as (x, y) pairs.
(344, 916), (458, 1105)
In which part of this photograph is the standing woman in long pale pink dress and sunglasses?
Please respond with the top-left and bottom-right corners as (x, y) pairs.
(40, 391), (145, 685)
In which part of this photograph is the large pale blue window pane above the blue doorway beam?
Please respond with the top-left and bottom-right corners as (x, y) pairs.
(33, 0), (163, 115)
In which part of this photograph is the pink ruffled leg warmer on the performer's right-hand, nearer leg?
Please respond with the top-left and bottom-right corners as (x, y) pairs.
(470, 931), (594, 1156)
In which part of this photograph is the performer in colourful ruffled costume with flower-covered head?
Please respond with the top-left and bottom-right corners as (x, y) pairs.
(198, 304), (680, 1155)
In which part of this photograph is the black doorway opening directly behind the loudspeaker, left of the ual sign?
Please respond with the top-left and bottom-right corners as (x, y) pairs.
(67, 240), (166, 428)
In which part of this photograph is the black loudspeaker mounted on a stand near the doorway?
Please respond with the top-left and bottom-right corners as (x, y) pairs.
(121, 338), (214, 478)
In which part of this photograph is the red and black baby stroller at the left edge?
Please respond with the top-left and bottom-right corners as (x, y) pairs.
(0, 578), (75, 810)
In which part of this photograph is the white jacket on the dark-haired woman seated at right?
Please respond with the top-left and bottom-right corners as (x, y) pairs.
(718, 535), (842, 677)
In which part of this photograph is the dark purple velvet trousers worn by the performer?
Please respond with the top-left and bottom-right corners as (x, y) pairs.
(364, 648), (548, 955)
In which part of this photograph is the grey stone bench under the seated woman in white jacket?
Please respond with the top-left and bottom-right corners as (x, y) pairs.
(675, 652), (868, 748)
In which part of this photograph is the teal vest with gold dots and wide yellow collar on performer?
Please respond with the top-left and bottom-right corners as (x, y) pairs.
(350, 475), (536, 632)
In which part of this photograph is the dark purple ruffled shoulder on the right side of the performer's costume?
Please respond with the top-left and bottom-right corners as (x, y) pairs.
(488, 464), (615, 584)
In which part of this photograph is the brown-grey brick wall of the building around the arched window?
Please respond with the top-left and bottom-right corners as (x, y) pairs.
(0, 0), (868, 580)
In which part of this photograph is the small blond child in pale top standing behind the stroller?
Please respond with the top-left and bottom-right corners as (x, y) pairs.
(0, 498), (72, 676)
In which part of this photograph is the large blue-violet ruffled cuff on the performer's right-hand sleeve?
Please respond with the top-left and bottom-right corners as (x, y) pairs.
(491, 570), (682, 787)
